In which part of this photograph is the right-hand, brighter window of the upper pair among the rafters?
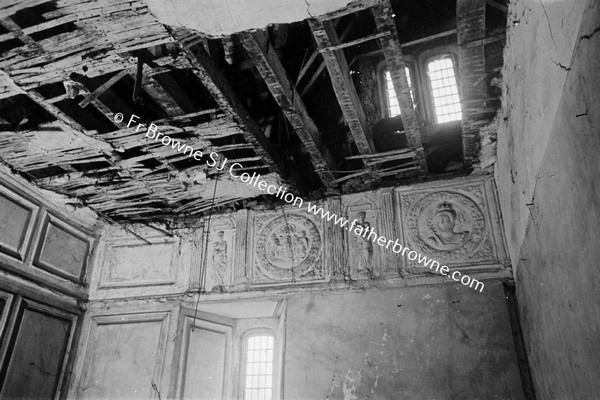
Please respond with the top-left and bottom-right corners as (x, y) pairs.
(427, 57), (462, 124)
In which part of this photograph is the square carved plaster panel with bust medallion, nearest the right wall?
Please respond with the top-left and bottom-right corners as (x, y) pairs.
(396, 177), (507, 271)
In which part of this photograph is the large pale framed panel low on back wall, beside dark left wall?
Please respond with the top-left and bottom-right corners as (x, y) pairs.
(77, 312), (170, 399)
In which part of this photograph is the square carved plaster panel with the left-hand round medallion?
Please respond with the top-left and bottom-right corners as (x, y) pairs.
(249, 210), (328, 284)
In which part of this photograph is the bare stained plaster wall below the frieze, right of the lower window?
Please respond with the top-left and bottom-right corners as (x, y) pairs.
(284, 282), (524, 400)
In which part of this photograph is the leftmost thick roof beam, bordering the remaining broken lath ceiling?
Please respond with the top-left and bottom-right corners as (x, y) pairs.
(173, 29), (284, 175)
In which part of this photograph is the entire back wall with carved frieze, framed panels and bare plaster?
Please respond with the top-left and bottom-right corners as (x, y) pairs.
(64, 177), (523, 399)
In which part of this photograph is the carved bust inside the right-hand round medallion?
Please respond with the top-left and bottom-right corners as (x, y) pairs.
(427, 201), (471, 248)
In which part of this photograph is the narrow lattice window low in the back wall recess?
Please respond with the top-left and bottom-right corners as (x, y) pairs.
(244, 333), (275, 400)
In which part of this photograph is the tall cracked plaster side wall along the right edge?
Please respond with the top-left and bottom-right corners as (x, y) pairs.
(496, 0), (600, 399)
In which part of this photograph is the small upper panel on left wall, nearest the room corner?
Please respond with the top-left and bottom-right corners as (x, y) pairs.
(33, 212), (94, 286)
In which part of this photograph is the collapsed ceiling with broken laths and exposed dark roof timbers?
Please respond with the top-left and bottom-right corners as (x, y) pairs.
(0, 0), (505, 221)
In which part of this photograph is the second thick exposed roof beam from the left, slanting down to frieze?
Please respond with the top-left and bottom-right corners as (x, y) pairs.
(240, 31), (335, 187)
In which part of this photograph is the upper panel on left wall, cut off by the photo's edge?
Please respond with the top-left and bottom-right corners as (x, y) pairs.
(0, 185), (39, 262)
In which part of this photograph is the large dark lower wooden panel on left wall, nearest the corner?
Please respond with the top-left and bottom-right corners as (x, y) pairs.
(0, 298), (77, 399)
